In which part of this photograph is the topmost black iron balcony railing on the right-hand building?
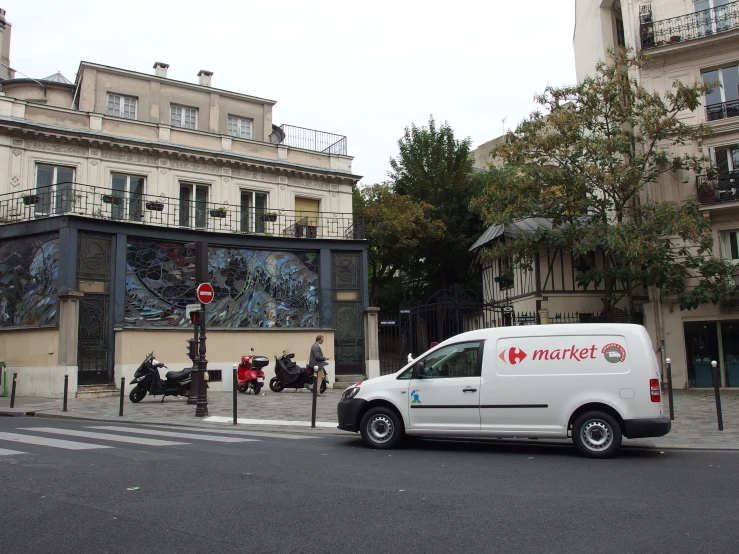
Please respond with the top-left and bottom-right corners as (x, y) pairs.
(640, 1), (739, 50)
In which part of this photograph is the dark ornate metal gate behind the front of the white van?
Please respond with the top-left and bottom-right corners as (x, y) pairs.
(378, 285), (496, 375)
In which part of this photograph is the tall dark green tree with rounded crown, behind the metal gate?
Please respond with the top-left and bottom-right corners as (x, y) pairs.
(388, 116), (482, 293)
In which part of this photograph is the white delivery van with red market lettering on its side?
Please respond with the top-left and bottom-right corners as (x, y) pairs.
(338, 323), (670, 458)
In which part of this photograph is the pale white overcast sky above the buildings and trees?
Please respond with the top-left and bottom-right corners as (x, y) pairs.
(7, 0), (575, 184)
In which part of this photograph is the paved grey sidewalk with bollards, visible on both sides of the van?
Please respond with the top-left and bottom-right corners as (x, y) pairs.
(0, 389), (739, 450)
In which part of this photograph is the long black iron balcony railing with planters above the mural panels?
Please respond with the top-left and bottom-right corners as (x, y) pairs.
(0, 183), (364, 239)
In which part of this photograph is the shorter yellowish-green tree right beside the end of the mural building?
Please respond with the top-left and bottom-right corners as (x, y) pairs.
(353, 183), (446, 306)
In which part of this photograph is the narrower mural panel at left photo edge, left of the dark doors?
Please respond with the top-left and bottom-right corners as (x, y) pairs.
(0, 234), (59, 327)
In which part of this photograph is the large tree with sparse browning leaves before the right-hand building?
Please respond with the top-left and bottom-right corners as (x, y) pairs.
(474, 50), (734, 313)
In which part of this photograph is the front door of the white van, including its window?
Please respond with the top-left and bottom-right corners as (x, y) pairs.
(408, 341), (484, 430)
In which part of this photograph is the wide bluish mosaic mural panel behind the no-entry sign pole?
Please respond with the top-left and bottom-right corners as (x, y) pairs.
(126, 238), (319, 328)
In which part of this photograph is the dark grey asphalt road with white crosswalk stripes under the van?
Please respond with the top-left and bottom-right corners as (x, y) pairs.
(0, 417), (739, 554)
